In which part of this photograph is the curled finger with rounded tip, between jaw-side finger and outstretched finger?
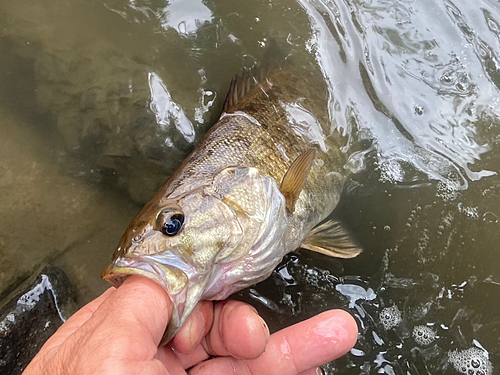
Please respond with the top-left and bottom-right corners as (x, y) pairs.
(202, 300), (269, 359)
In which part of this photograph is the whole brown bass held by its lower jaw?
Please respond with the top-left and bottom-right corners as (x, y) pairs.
(102, 67), (362, 344)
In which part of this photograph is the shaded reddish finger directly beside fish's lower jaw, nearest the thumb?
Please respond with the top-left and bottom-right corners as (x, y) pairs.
(170, 301), (214, 354)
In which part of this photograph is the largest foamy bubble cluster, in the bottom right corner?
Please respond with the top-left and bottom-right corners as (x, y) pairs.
(448, 347), (493, 375)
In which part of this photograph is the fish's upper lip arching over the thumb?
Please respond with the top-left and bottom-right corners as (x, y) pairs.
(101, 258), (166, 288)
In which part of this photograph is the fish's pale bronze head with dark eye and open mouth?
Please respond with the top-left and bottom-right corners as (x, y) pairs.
(102, 167), (286, 342)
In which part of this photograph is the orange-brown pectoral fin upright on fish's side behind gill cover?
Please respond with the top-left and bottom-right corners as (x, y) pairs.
(280, 147), (316, 213)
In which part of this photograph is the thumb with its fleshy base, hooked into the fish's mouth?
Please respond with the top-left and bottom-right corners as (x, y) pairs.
(25, 276), (172, 374)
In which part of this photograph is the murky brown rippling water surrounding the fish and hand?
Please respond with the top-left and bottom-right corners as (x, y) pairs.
(0, 0), (500, 375)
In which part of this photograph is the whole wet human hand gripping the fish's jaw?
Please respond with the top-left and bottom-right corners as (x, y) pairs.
(24, 276), (357, 375)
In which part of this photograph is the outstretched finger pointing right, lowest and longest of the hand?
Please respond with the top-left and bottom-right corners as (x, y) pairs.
(190, 310), (358, 375)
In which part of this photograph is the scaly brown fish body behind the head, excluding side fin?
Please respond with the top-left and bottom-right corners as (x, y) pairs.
(155, 71), (346, 252)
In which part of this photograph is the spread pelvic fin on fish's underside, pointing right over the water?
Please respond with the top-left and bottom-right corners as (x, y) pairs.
(301, 220), (363, 259)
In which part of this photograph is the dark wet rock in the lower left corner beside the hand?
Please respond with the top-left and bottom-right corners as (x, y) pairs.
(0, 266), (76, 375)
